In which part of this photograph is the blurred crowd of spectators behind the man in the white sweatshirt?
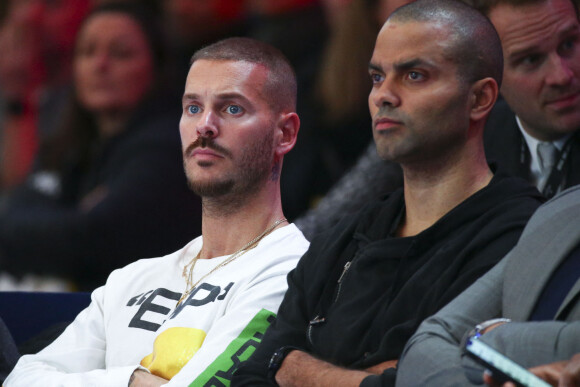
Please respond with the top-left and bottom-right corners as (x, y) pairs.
(0, 0), (396, 290)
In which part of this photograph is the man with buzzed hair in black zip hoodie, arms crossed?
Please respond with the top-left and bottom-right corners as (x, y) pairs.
(232, 0), (541, 386)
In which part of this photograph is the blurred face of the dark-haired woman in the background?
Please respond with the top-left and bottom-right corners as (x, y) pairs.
(74, 12), (154, 118)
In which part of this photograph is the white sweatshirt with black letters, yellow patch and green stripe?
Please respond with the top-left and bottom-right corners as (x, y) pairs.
(4, 224), (308, 387)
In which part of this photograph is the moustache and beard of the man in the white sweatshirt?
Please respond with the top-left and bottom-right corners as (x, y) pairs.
(185, 130), (274, 200)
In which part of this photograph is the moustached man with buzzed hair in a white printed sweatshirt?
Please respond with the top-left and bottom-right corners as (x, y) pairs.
(4, 38), (308, 387)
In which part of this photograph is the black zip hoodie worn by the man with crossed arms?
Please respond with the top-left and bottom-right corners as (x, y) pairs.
(232, 174), (543, 386)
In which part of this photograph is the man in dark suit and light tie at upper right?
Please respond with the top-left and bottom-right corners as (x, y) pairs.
(480, 0), (580, 197)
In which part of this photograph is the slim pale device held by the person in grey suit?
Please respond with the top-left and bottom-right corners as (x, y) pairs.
(464, 335), (550, 387)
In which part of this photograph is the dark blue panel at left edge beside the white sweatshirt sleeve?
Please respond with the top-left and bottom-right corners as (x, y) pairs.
(0, 292), (91, 345)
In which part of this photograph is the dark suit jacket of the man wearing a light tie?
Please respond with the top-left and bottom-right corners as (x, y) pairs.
(483, 99), (580, 192)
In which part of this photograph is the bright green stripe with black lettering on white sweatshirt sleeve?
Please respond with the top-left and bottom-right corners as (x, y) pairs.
(189, 309), (276, 387)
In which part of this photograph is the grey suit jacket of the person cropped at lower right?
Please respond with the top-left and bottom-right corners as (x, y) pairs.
(397, 186), (580, 386)
